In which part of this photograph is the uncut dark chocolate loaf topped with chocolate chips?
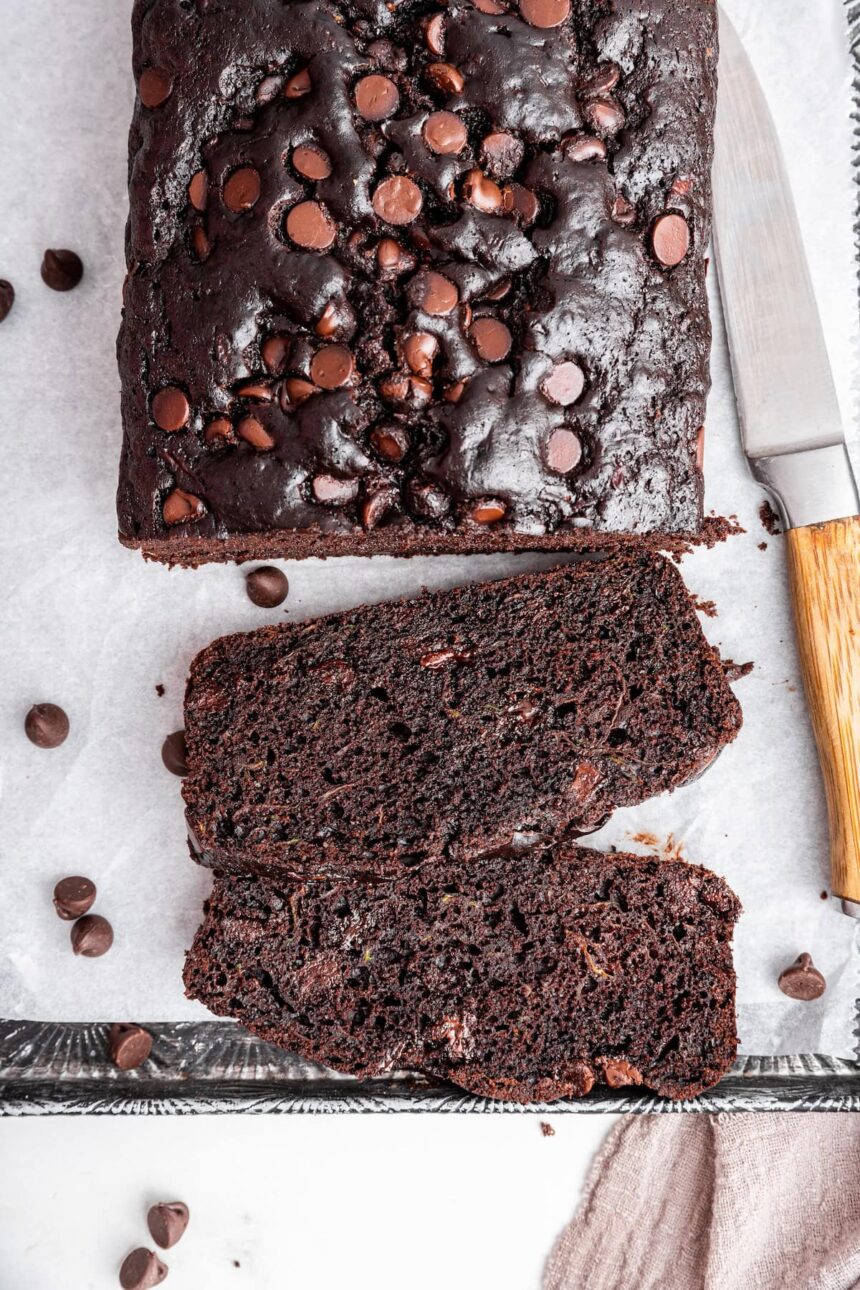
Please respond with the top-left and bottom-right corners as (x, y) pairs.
(119, 0), (717, 565)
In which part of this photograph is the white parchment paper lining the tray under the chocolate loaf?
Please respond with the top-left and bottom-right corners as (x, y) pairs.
(0, 0), (860, 1057)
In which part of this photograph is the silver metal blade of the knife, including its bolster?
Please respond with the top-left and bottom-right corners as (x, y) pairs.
(713, 10), (860, 528)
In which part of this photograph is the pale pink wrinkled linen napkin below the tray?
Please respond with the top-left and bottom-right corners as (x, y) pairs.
(543, 1112), (860, 1290)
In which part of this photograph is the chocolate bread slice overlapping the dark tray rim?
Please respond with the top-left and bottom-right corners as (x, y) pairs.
(184, 845), (740, 1102)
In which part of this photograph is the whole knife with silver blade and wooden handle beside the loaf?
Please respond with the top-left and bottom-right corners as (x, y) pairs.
(713, 10), (860, 918)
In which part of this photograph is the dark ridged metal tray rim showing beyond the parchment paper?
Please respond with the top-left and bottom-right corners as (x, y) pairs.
(0, 0), (860, 1116)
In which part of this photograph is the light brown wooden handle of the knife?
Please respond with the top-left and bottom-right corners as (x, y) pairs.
(785, 516), (860, 902)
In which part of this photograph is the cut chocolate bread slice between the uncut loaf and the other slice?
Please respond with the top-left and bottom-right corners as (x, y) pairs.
(183, 553), (741, 877)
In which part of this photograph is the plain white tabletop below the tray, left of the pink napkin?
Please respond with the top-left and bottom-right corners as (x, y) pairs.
(0, 1115), (618, 1290)
